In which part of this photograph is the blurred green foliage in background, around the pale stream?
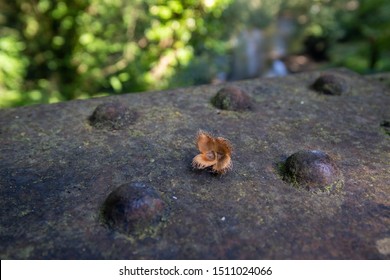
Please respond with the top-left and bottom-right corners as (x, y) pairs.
(0, 0), (390, 107)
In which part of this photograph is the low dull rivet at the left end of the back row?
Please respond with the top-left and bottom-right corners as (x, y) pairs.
(89, 102), (138, 130)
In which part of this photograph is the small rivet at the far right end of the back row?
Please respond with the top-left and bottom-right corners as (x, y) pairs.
(313, 73), (349, 95)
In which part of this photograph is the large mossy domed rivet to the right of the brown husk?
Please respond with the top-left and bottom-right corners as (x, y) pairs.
(284, 150), (344, 192)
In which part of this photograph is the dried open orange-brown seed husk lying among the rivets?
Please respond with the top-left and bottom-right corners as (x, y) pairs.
(192, 131), (233, 174)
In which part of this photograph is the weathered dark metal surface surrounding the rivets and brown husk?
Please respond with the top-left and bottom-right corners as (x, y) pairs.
(0, 70), (390, 260)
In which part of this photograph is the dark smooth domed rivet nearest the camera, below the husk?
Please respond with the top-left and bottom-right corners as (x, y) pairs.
(103, 182), (166, 234)
